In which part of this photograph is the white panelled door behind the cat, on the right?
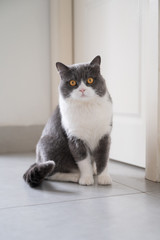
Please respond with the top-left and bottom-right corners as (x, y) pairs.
(74, 0), (147, 167)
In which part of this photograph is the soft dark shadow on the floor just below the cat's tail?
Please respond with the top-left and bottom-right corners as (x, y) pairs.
(36, 181), (77, 195)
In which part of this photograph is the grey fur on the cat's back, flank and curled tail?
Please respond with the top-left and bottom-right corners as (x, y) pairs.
(23, 106), (78, 187)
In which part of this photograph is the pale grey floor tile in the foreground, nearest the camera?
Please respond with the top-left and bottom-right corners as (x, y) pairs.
(0, 193), (160, 240)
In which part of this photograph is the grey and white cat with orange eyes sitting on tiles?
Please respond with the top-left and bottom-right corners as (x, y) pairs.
(23, 56), (112, 187)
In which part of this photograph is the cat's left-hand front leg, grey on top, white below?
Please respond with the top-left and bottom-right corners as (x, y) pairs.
(69, 137), (94, 185)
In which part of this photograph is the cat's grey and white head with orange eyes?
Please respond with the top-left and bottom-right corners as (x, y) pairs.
(56, 56), (107, 101)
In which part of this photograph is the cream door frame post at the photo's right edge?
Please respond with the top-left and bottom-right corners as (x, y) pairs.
(146, 0), (160, 182)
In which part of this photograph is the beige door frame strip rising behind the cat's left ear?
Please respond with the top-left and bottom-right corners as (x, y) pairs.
(50, 0), (73, 111)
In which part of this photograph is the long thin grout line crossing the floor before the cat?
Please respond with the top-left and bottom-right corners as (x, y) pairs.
(0, 192), (143, 211)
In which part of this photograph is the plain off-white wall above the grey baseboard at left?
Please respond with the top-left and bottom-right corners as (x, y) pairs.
(0, 0), (51, 126)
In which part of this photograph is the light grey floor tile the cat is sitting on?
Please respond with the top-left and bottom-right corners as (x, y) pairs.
(0, 154), (139, 208)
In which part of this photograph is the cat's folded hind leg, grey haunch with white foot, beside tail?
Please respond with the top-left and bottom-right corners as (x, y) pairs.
(37, 135), (80, 182)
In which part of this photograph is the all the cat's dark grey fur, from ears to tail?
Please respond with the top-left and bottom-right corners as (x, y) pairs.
(24, 56), (110, 187)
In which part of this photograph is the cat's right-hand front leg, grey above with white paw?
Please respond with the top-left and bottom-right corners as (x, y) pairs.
(94, 135), (112, 185)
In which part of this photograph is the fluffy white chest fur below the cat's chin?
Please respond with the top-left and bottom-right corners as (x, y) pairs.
(59, 95), (112, 150)
